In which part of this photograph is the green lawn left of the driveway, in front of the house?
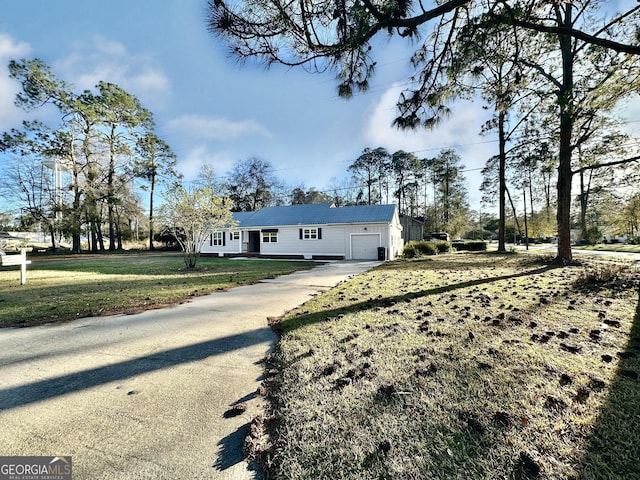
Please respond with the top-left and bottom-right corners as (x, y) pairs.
(0, 254), (312, 327)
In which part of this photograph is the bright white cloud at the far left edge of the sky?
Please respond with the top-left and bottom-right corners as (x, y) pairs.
(0, 32), (31, 131)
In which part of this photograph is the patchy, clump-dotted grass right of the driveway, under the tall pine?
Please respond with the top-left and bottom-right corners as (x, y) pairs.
(256, 254), (640, 480)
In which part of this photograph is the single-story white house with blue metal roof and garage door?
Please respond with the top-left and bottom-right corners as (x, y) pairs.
(200, 203), (403, 260)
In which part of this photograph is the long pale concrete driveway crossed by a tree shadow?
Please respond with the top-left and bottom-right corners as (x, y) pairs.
(0, 260), (379, 480)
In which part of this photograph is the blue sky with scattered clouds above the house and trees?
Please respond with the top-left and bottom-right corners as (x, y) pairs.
(0, 0), (640, 214)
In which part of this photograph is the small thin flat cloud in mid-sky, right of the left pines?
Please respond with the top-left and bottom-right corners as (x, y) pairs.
(167, 115), (271, 140)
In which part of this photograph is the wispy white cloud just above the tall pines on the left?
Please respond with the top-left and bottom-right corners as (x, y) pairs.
(54, 36), (171, 110)
